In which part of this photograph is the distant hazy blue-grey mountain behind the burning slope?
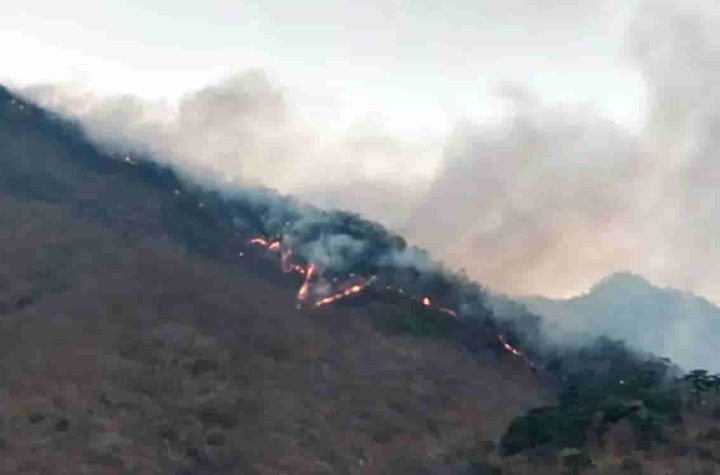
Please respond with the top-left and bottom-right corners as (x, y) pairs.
(522, 272), (720, 371)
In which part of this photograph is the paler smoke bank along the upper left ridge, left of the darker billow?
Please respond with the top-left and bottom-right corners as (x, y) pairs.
(23, 71), (432, 232)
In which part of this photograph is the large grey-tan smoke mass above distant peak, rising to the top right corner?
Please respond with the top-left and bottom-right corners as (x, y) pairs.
(409, 1), (720, 302)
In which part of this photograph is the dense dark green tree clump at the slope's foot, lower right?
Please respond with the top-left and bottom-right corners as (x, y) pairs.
(501, 339), (682, 455)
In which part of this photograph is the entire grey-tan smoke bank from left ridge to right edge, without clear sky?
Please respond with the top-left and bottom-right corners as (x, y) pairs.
(16, 0), (720, 308)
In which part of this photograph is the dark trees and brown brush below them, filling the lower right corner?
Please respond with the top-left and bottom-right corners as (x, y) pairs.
(496, 339), (720, 474)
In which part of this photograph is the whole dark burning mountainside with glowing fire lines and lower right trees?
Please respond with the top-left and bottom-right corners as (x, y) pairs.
(5, 87), (720, 475)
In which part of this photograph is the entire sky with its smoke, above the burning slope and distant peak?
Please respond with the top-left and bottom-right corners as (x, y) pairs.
(5, 0), (720, 302)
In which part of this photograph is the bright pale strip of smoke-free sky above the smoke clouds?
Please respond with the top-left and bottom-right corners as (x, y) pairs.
(0, 0), (642, 136)
